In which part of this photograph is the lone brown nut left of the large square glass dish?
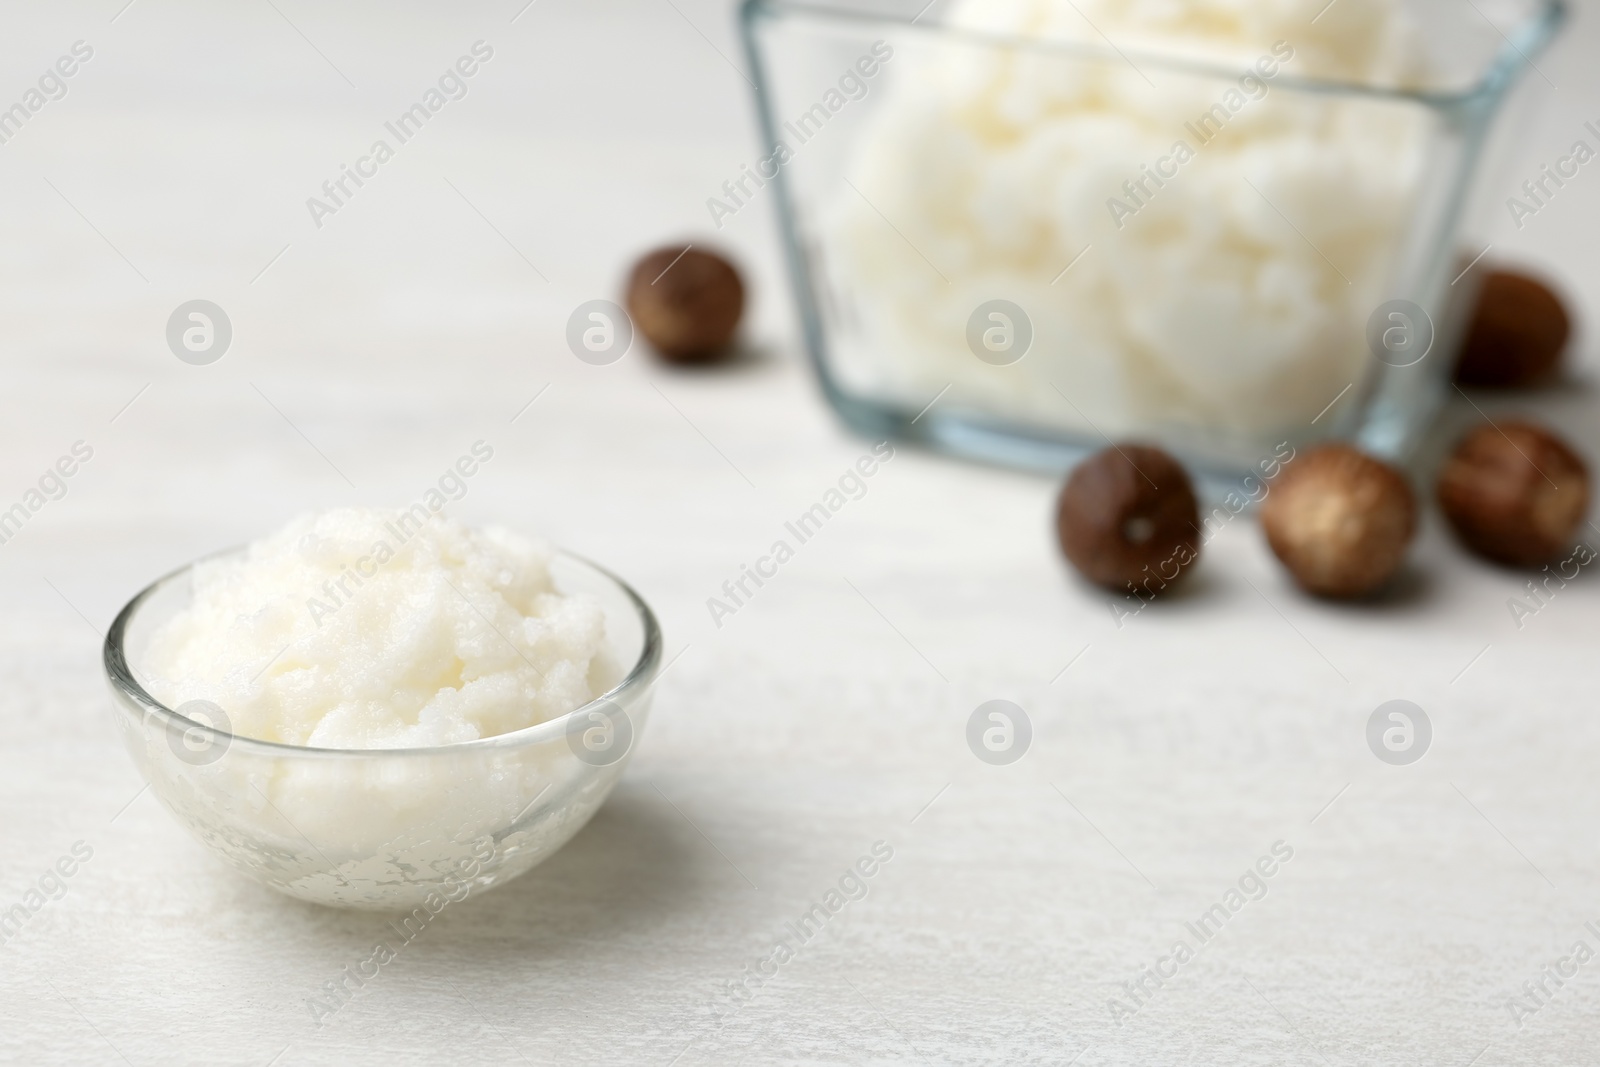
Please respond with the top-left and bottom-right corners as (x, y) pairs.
(627, 245), (744, 363)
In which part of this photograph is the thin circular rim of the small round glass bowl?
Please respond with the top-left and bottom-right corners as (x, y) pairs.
(101, 545), (661, 760)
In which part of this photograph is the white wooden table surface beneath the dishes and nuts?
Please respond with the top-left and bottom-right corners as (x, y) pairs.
(0, 0), (1600, 1067)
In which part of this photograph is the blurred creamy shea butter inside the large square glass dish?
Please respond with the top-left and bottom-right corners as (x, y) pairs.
(822, 0), (1429, 454)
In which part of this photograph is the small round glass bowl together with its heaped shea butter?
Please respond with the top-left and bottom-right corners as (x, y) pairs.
(104, 509), (661, 913)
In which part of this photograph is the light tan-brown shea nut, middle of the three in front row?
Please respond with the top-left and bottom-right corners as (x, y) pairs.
(1261, 445), (1416, 598)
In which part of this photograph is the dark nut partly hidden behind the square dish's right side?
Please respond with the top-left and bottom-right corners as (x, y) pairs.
(1456, 270), (1571, 389)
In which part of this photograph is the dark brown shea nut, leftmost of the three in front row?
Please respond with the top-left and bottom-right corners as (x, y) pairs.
(1056, 445), (1200, 597)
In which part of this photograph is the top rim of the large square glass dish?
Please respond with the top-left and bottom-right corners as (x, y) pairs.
(739, 0), (1571, 107)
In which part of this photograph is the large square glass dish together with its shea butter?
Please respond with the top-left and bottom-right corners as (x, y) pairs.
(742, 0), (1563, 477)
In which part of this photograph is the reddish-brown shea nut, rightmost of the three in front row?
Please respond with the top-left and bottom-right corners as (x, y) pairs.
(1438, 422), (1589, 566)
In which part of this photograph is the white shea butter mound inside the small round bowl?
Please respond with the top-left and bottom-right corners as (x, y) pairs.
(142, 509), (616, 749)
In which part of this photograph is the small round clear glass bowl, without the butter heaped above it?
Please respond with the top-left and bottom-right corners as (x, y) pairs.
(104, 552), (661, 913)
